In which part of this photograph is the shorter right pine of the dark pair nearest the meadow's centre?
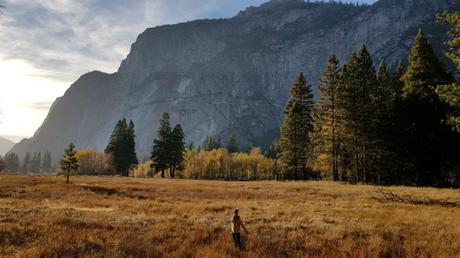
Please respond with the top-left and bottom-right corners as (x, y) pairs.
(169, 124), (185, 178)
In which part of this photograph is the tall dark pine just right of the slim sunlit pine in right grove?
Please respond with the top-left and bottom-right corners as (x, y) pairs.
(339, 46), (377, 183)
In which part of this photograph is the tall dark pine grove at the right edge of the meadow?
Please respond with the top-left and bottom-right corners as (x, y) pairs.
(279, 31), (460, 186)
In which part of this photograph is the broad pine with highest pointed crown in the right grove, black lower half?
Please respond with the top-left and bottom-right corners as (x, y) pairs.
(402, 31), (459, 185)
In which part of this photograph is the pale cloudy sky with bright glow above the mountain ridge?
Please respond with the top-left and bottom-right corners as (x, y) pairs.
(0, 0), (374, 142)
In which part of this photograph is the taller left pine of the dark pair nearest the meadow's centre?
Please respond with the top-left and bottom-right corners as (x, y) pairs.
(151, 113), (172, 178)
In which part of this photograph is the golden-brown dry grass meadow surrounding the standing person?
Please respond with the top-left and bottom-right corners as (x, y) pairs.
(0, 175), (460, 257)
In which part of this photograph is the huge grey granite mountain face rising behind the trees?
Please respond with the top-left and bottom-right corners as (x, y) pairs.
(12, 0), (458, 159)
